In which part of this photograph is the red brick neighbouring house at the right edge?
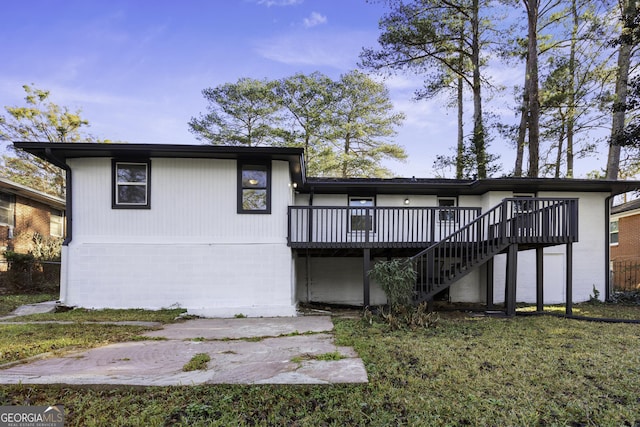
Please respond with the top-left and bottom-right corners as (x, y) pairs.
(609, 199), (640, 289)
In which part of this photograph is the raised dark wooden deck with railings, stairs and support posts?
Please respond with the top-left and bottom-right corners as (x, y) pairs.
(288, 197), (578, 314)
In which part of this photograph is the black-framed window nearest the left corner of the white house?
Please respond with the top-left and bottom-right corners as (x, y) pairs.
(112, 161), (151, 209)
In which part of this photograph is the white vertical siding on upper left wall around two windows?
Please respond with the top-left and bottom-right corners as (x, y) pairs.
(69, 159), (291, 244)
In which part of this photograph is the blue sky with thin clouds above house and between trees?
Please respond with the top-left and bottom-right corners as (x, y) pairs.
(0, 0), (606, 177)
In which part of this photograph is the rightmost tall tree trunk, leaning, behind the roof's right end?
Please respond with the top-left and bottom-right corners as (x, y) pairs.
(606, 0), (637, 180)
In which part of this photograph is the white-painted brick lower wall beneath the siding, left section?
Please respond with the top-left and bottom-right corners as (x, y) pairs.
(64, 243), (295, 317)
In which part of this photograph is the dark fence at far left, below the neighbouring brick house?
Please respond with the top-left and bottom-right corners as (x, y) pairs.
(0, 259), (60, 292)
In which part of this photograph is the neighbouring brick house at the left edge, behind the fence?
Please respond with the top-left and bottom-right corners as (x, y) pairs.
(0, 178), (65, 253)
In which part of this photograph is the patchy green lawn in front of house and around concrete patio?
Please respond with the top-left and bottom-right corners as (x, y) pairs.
(0, 304), (640, 426)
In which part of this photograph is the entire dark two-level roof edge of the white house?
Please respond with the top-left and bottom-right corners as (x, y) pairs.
(14, 142), (640, 196)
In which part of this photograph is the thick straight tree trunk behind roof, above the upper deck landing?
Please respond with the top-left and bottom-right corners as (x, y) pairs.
(523, 0), (540, 178)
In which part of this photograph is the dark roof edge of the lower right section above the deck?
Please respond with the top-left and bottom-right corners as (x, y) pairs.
(299, 178), (640, 196)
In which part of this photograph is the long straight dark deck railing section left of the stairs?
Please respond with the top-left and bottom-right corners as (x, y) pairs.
(288, 206), (481, 248)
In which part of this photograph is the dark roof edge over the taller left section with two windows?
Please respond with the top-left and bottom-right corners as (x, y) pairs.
(13, 142), (305, 187)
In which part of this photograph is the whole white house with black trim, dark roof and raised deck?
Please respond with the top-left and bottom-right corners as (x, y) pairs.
(15, 142), (640, 316)
